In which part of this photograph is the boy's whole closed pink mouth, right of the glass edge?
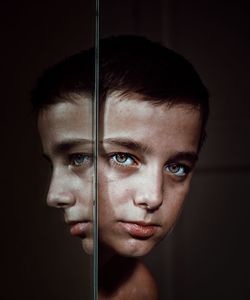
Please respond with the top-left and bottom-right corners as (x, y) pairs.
(119, 221), (159, 239)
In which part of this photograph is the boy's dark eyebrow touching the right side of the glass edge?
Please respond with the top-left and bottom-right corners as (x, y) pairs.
(100, 138), (152, 153)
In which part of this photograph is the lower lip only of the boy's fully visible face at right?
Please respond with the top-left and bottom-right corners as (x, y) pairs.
(120, 222), (157, 238)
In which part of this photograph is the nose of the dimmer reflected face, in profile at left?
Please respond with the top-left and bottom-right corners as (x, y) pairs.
(47, 171), (75, 208)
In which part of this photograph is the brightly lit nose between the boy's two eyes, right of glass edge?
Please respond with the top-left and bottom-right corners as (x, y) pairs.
(134, 169), (164, 211)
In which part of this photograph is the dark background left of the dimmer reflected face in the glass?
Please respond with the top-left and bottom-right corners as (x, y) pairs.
(0, 0), (95, 300)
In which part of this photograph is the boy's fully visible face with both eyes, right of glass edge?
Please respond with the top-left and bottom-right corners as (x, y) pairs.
(99, 95), (201, 257)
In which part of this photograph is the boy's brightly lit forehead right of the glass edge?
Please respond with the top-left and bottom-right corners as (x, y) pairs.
(102, 95), (201, 151)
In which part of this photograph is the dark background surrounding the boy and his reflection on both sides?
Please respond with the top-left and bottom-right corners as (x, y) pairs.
(0, 0), (250, 300)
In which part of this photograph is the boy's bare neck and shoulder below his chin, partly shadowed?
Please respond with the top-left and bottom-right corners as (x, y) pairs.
(99, 258), (159, 300)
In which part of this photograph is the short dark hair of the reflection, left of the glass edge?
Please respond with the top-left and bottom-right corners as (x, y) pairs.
(31, 49), (95, 108)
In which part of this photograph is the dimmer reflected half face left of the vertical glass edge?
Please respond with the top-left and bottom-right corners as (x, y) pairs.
(38, 95), (93, 254)
